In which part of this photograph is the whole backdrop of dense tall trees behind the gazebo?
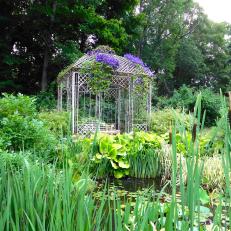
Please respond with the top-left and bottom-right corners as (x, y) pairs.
(0, 0), (231, 95)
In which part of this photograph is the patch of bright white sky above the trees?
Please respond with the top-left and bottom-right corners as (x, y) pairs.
(195, 0), (231, 23)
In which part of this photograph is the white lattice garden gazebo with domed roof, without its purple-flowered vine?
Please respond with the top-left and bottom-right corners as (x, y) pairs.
(58, 46), (152, 135)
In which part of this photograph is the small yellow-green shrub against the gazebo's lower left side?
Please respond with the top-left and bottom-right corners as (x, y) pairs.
(38, 111), (69, 137)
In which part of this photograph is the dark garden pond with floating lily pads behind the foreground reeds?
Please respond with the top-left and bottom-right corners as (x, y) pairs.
(94, 177), (229, 230)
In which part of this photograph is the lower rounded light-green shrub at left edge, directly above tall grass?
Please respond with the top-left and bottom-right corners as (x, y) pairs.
(0, 115), (56, 154)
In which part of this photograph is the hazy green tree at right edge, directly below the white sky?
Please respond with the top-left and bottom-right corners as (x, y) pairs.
(181, 12), (231, 91)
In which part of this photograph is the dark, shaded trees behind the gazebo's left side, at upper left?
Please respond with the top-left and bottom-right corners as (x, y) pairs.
(0, 0), (135, 93)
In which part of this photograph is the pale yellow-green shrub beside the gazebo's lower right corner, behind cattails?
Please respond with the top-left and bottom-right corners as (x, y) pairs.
(150, 108), (193, 134)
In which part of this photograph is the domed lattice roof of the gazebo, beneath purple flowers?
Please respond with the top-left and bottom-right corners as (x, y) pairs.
(58, 46), (151, 80)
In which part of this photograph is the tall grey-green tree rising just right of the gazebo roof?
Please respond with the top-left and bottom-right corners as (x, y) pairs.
(137, 0), (196, 94)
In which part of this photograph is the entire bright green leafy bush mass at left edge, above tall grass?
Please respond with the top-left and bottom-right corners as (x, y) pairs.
(0, 94), (56, 155)
